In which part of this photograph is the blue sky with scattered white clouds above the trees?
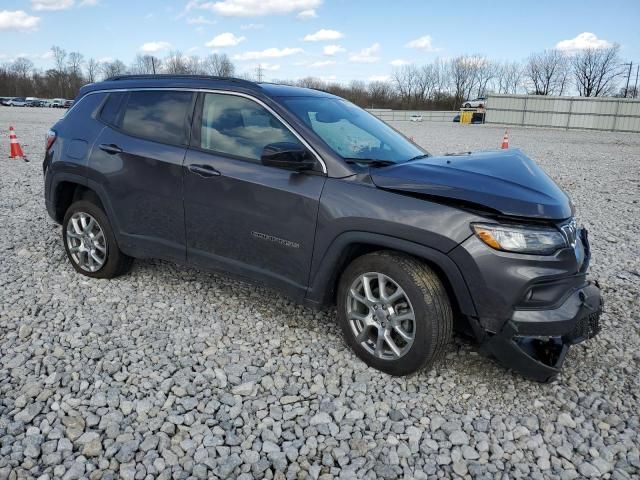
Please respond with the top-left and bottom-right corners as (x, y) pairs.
(0, 0), (640, 81)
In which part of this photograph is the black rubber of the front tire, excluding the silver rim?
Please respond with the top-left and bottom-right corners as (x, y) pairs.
(337, 251), (453, 376)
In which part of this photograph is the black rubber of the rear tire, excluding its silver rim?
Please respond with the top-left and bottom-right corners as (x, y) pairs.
(62, 200), (133, 278)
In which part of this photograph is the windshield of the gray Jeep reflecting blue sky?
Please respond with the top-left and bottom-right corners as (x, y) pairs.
(282, 97), (426, 163)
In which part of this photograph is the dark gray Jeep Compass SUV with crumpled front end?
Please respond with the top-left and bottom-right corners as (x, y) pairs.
(43, 75), (601, 381)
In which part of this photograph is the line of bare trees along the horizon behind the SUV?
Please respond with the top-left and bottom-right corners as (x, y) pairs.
(0, 45), (637, 110)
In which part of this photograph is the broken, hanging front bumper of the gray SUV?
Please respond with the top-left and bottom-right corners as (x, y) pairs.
(481, 282), (603, 382)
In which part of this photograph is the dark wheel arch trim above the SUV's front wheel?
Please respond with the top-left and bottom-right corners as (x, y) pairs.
(307, 232), (477, 316)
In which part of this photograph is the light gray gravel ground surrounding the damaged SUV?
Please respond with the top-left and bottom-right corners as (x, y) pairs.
(0, 107), (640, 479)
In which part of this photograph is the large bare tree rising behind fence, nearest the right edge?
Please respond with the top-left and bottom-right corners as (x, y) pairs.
(571, 44), (621, 97)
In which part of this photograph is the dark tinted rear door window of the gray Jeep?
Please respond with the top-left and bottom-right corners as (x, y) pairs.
(121, 91), (192, 144)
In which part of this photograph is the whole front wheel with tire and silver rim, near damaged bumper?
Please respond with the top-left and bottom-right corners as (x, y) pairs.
(337, 252), (453, 375)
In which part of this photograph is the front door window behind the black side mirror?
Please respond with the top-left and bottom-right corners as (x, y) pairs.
(200, 93), (300, 162)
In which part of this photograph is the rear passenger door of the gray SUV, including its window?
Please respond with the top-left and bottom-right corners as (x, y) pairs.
(89, 90), (194, 261)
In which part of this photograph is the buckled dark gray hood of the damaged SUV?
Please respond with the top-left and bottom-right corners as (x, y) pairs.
(371, 149), (572, 220)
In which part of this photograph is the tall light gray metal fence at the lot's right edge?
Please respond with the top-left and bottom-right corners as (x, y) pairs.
(486, 95), (640, 132)
